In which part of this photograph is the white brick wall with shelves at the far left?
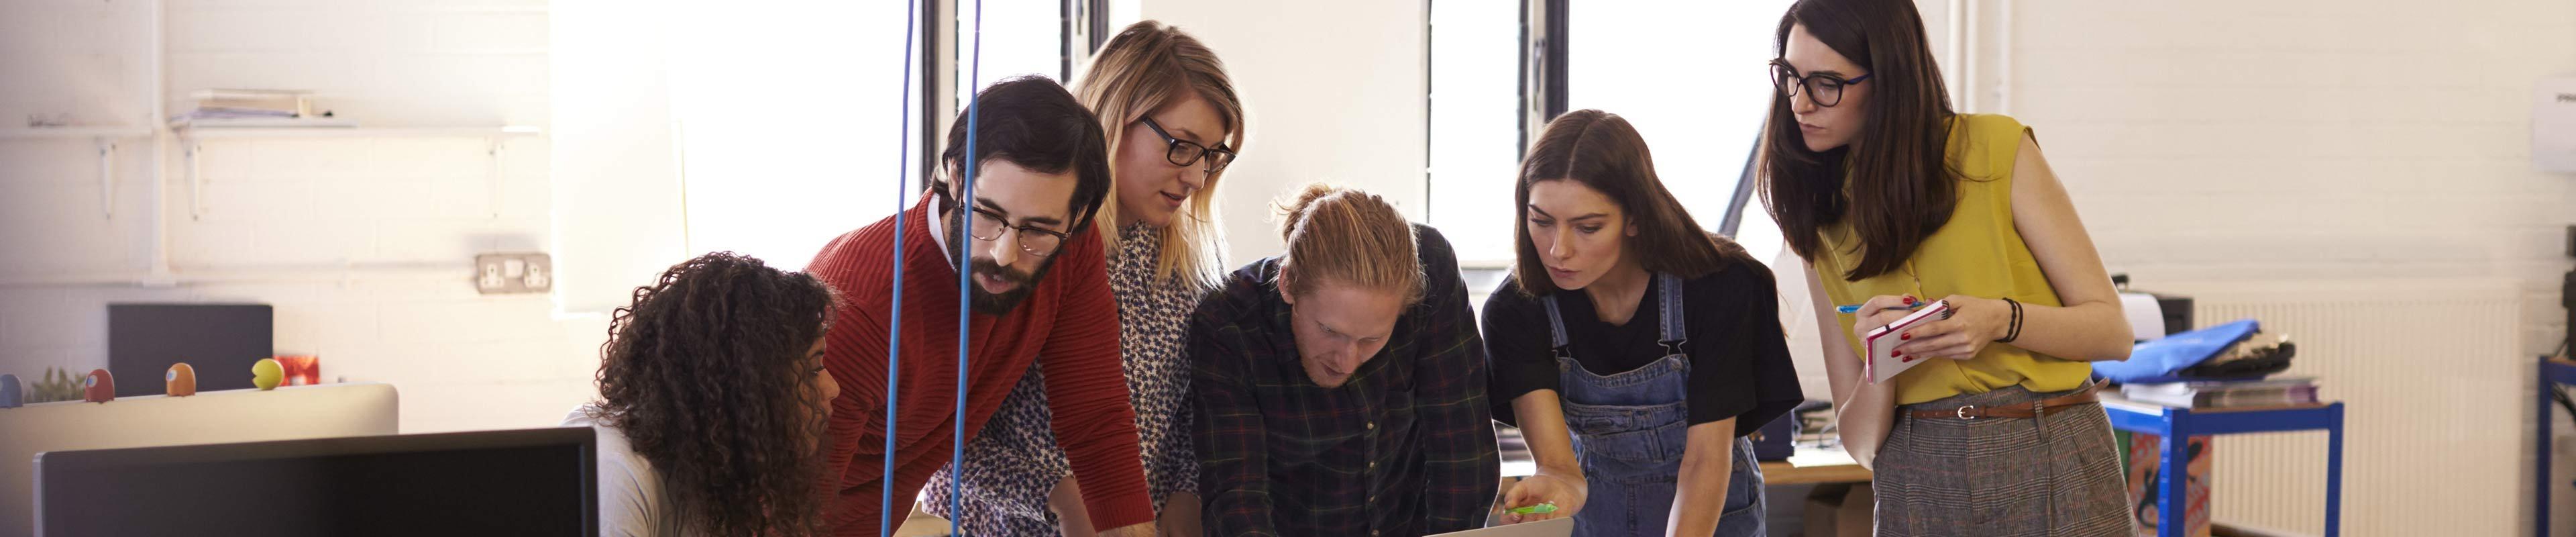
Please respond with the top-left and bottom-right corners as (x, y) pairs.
(0, 0), (584, 431)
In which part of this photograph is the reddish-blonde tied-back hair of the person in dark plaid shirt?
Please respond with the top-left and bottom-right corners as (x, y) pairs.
(1280, 183), (1425, 307)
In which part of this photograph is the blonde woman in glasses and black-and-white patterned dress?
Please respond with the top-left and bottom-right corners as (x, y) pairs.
(922, 21), (1244, 534)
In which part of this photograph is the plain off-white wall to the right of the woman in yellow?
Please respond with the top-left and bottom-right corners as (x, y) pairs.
(1973, 0), (2576, 534)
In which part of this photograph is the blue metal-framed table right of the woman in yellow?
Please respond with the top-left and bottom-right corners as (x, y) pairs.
(2102, 397), (2344, 537)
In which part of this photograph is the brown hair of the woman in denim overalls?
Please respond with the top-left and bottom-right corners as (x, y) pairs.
(1512, 109), (1754, 297)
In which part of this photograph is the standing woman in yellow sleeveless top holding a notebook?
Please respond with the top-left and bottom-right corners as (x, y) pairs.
(1760, 0), (2133, 534)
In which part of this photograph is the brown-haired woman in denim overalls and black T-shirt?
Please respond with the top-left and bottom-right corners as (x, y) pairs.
(1484, 111), (1801, 537)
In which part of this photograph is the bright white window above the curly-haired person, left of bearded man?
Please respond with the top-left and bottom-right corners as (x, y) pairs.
(667, 0), (920, 271)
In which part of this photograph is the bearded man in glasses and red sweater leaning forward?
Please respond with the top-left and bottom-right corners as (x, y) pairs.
(806, 77), (1154, 534)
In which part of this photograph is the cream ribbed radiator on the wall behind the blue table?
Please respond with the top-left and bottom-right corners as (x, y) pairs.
(2190, 281), (2535, 534)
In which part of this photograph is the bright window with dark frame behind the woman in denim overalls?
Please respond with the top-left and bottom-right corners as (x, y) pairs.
(1430, 0), (1790, 266)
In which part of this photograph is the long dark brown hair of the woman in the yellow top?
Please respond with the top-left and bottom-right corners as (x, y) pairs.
(1757, 0), (1960, 281)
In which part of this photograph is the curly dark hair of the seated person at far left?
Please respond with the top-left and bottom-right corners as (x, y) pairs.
(595, 253), (835, 534)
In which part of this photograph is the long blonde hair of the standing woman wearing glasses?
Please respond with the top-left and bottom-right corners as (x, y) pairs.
(1074, 21), (1244, 289)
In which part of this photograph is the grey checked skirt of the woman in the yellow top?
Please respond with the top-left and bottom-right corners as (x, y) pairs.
(1870, 387), (2138, 537)
